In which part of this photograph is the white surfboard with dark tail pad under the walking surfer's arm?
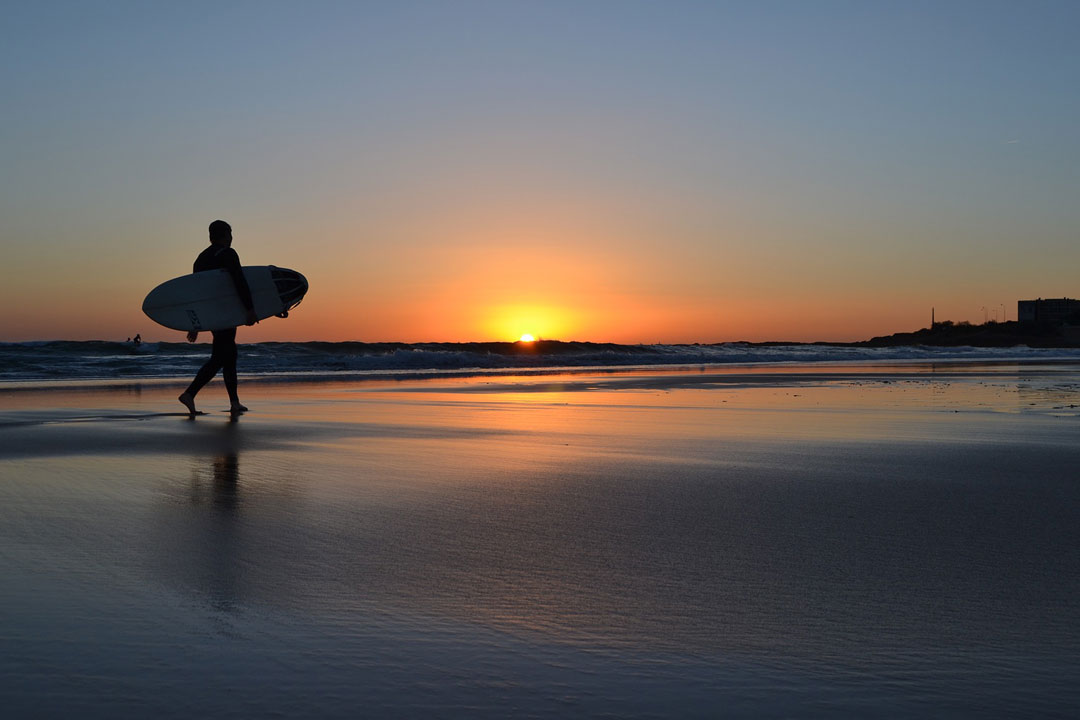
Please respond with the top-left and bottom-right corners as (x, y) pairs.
(143, 264), (308, 331)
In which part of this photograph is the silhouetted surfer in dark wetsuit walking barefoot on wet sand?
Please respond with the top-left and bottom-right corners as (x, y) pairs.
(181, 220), (258, 415)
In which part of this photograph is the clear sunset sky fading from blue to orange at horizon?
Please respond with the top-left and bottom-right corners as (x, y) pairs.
(0, 0), (1080, 342)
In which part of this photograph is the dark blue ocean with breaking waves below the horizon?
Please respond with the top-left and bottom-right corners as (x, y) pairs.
(0, 341), (1080, 381)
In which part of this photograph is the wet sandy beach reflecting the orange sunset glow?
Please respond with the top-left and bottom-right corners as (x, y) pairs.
(0, 361), (1080, 718)
